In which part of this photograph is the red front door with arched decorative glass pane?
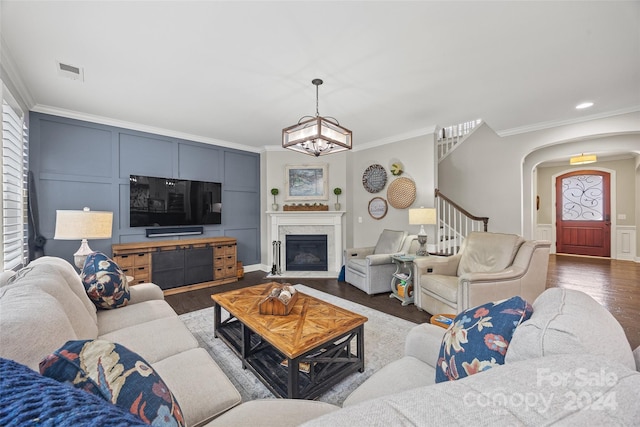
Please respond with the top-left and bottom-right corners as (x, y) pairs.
(556, 170), (611, 257)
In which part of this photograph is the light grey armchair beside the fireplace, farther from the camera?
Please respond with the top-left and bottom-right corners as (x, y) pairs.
(345, 230), (418, 295)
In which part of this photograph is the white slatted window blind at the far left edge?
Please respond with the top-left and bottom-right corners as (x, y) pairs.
(2, 99), (28, 270)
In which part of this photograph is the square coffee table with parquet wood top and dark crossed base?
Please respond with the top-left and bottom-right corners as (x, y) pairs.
(211, 282), (368, 399)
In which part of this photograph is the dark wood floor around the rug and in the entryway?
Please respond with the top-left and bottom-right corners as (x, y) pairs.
(165, 255), (640, 348)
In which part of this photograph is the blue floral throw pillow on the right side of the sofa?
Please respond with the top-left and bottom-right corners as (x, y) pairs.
(436, 296), (533, 383)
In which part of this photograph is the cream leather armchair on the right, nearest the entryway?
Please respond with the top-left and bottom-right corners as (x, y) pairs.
(413, 232), (551, 314)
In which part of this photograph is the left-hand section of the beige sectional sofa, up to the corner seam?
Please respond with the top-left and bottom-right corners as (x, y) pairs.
(0, 257), (241, 426)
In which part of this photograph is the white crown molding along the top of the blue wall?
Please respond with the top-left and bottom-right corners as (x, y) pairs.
(31, 104), (262, 153)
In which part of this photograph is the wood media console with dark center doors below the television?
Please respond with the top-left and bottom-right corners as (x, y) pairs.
(111, 237), (238, 295)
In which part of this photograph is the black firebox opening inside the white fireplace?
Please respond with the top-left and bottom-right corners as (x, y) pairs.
(285, 234), (328, 271)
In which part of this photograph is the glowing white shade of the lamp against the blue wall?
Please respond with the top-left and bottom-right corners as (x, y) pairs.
(53, 208), (113, 240)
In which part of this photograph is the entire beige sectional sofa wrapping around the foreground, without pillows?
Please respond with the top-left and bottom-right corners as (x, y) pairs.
(0, 257), (640, 427)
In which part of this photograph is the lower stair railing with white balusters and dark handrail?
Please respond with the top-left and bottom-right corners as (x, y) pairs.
(436, 189), (489, 256)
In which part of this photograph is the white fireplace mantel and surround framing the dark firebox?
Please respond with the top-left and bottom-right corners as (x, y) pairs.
(267, 211), (345, 275)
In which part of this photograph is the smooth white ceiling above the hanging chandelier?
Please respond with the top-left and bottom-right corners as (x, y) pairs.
(1, 0), (640, 150)
